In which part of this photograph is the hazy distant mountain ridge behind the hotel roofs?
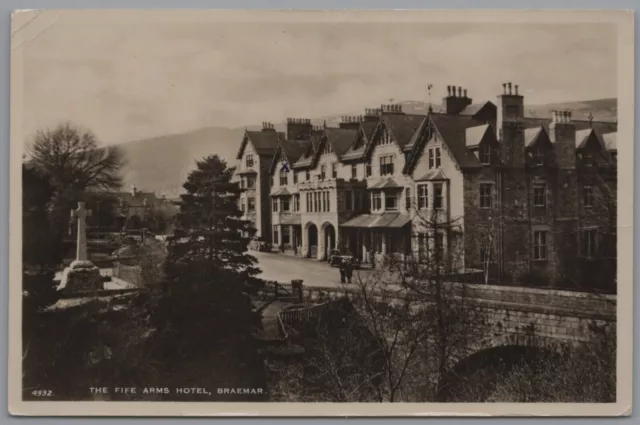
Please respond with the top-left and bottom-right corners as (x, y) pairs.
(120, 99), (617, 197)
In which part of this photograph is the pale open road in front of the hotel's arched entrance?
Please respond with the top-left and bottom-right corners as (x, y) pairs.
(249, 251), (369, 287)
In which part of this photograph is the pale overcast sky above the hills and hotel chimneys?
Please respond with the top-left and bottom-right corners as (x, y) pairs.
(13, 12), (616, 143)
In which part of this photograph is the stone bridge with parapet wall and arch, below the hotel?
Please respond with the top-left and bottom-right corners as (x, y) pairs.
(264, 283), (616, 368)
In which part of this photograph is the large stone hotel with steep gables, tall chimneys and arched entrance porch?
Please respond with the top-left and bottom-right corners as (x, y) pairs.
(236, 83), (617, 281)
